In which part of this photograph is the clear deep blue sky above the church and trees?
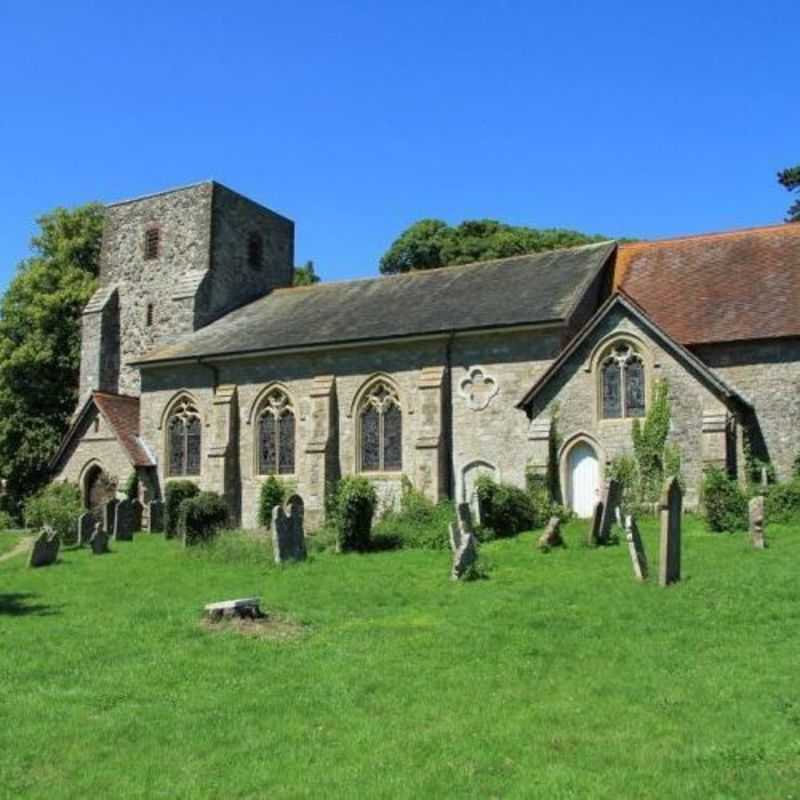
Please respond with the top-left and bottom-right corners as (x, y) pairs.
(0, 0), (800, 287)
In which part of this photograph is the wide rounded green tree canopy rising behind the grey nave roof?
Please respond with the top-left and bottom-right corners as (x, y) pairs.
(380, 219), (609, 275)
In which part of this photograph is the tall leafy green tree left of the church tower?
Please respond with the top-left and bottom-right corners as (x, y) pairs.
(0, 204), (103, 513)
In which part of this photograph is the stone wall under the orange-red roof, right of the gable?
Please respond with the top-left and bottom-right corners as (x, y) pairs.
(694, 339), (800, 480)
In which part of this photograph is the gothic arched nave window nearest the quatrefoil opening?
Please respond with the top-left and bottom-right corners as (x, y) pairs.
(359, 381), (403, 472)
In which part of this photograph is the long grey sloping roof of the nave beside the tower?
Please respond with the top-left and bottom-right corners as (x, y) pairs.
(132, 242), (616, 365)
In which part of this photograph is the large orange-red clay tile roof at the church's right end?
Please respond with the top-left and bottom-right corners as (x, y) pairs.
(614, 223), (800, 345)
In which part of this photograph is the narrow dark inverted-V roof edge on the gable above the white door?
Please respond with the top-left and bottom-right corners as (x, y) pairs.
(517, 291), (752, 411)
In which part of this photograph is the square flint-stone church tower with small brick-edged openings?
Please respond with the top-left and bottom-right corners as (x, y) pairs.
(79, 181), (294, 400)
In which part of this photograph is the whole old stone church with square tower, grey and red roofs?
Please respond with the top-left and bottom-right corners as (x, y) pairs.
(51, 182), (800, 530)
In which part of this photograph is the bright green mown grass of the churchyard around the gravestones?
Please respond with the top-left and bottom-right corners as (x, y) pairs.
(0, 518), (800, 799)
